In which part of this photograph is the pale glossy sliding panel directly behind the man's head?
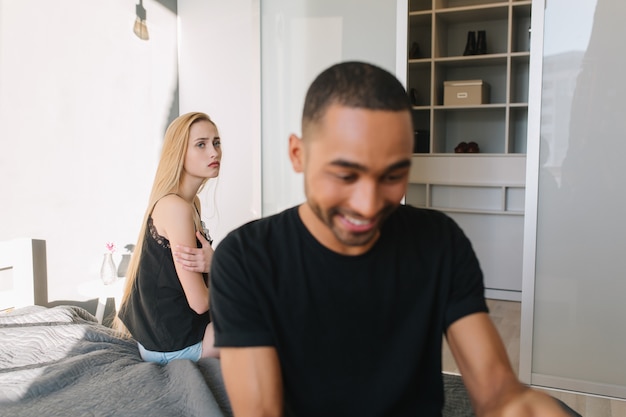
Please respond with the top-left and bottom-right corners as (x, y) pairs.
(261, 0), (406, 215)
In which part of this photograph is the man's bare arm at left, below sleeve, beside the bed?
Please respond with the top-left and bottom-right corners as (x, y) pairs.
(220, 346), (283, 417)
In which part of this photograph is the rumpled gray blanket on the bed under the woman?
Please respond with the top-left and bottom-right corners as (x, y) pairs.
(0, 306), (231, 417)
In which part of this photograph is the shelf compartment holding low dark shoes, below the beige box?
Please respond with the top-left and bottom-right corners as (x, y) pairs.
(432, 106), (506, 155)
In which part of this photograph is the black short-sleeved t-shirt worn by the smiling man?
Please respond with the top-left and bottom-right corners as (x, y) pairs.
(211, 206), (487, 417)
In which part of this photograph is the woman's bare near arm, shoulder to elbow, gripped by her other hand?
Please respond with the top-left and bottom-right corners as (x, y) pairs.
(152, 194), (209, 314)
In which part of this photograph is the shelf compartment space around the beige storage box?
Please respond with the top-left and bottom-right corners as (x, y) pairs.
(434, 57), (507, 105)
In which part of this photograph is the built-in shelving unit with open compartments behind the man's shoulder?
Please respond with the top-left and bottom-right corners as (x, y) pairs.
(406, 0), (532, 300)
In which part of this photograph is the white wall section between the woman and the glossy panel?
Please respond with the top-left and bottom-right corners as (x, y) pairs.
(178, 0), (261, 240)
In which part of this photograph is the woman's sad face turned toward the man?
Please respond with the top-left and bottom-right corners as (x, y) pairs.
(183, 120), (222, 178)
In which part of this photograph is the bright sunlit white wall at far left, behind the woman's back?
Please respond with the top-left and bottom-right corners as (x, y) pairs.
(0, 0), (177, 301)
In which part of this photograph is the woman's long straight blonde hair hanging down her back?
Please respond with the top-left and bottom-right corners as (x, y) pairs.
(113, 112), (215, 336)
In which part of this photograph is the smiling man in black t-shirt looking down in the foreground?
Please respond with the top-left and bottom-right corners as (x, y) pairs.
(211, 62), (565, 417)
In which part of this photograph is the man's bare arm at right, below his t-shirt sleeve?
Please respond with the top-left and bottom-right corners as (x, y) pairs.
(446, 313), (568, 417)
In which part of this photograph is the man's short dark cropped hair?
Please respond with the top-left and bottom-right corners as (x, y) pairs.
(302, 61), (411, 130)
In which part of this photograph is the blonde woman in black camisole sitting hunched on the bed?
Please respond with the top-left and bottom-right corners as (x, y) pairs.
(117, 112), (222, 364)
